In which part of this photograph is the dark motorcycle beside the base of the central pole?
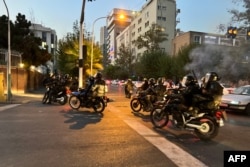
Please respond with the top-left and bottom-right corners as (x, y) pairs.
(69, 77), (108, 113)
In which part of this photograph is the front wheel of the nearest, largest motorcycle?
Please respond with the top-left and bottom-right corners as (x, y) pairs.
(150, 109), (169, 128)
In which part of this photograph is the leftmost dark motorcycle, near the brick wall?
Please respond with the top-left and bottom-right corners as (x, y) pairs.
(42, 84), (69, 105)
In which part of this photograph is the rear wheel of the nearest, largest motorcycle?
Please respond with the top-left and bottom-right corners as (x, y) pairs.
(194, 116), (219, 141)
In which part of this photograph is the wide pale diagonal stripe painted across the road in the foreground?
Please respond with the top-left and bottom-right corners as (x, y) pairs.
(108, 105), (207, 167)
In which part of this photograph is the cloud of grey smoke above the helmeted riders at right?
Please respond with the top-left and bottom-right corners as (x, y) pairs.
(185, 45), (249, 82)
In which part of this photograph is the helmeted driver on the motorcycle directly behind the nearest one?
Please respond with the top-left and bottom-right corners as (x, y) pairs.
(145, 78), (157, 111)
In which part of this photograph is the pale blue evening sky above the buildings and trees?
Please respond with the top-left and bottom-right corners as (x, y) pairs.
(0, 0), (242, 41)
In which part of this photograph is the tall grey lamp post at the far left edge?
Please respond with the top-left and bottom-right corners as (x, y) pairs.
(3, 0), (11, 101)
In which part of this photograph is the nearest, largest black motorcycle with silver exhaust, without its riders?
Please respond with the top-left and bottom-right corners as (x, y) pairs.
(150, 92), (227, 141)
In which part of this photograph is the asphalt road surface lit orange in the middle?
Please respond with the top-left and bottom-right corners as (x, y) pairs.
(0, 86), (250, 167)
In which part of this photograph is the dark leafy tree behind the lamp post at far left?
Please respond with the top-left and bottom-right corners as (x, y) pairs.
(0, 13), (52, 68)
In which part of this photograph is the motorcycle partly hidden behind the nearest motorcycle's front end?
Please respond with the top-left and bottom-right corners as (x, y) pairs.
(130, 91), (155, 112)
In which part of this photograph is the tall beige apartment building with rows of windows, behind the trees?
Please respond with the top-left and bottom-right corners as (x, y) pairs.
(115, 0), (176, 60)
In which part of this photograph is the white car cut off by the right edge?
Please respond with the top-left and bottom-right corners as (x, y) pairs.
(220, 85), (250, 115)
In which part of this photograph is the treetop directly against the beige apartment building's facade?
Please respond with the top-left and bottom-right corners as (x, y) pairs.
(135, 24), (168, 52)
